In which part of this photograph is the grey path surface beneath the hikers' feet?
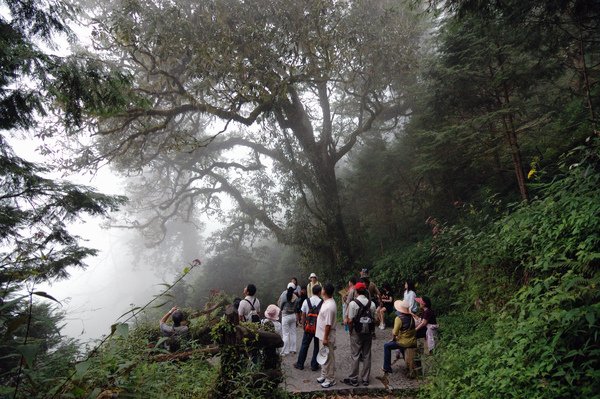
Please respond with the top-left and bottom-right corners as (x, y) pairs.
(282, 325), (420, 393)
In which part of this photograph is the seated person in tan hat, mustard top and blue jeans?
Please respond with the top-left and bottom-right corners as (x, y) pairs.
(382, 300), (417, 373)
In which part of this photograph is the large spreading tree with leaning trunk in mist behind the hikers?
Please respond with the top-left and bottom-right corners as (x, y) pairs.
(61, 0), (423, 276)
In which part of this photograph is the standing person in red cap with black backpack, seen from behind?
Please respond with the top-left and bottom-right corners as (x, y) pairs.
(344, 282), (375, 387)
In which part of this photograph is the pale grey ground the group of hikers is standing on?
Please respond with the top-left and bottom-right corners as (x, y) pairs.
(281, 326), (428, 399)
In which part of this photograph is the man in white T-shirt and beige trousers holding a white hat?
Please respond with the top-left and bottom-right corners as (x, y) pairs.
(315, 283), (337, 388)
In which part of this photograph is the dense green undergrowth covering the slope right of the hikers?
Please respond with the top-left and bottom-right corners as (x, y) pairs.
(408, 148), (600, 398)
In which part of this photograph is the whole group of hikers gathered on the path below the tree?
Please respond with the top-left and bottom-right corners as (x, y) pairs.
(160, 268), (438, 388)
